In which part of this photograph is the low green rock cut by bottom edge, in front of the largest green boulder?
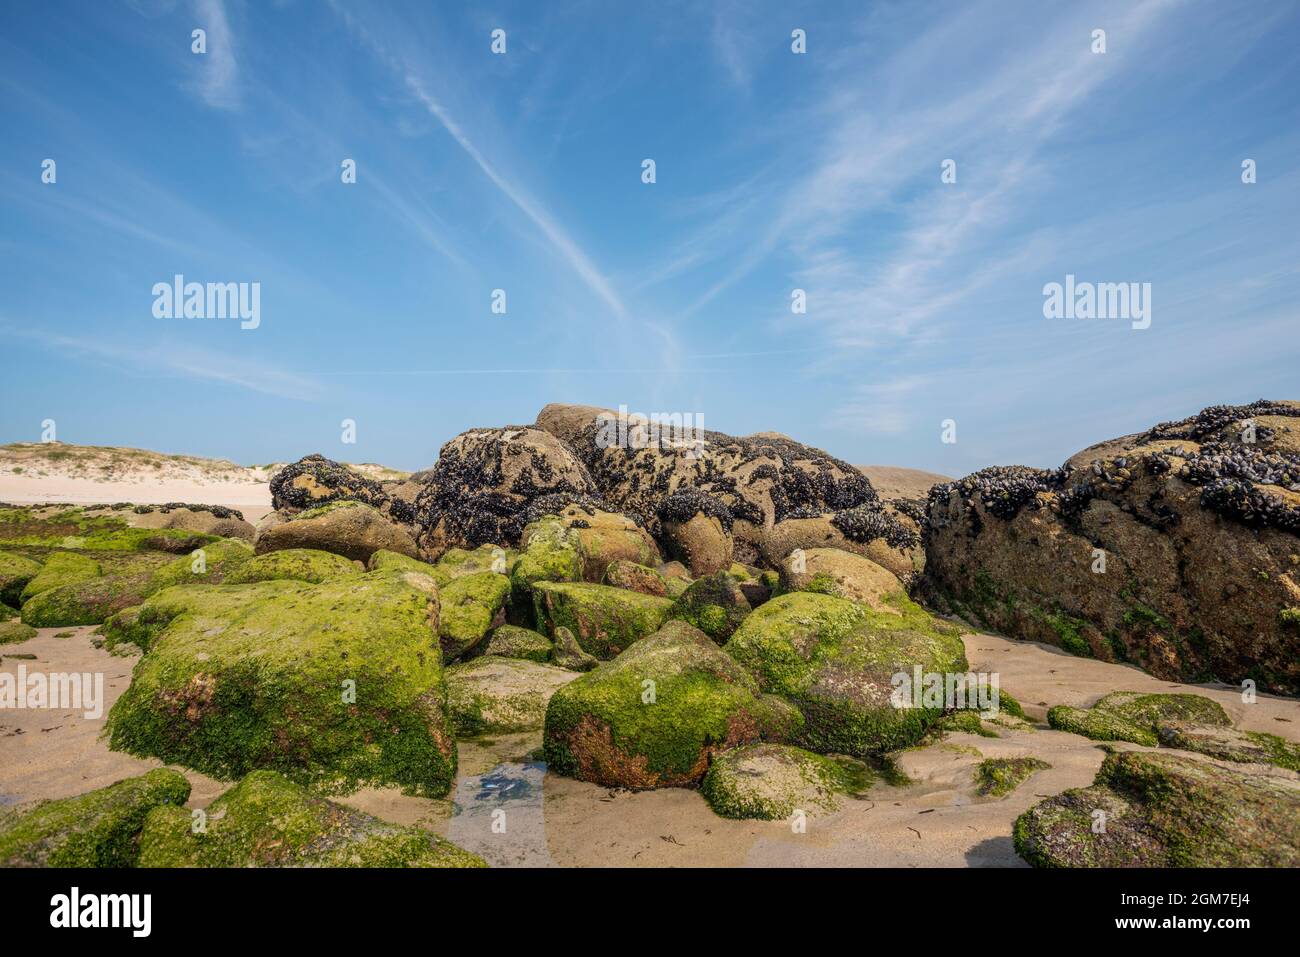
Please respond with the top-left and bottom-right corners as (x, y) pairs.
(140, 771), (486, 867)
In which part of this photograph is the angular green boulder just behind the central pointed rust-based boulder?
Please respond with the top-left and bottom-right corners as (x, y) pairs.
(533, 581), (672, 659)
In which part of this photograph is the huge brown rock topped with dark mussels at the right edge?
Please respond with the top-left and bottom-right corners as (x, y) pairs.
(923, 400), (1300, 694)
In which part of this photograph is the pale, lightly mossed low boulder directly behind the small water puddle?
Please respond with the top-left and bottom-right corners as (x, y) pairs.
(447, 655), (577, 736)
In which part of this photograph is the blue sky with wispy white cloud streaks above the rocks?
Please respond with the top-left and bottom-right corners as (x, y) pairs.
(0, 0), (1300, 475)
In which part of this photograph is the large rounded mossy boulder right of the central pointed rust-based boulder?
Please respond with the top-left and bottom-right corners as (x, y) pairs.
(724, 592), (966, 757)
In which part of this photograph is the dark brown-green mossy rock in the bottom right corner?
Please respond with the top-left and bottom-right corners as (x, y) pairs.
(1014, 752), (1300, 867)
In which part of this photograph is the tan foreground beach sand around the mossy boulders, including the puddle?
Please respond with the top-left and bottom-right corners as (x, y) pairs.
(0, 627), (1300, 867)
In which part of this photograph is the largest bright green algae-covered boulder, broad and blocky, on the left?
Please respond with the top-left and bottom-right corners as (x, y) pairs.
(108, 572), (456, 797)
